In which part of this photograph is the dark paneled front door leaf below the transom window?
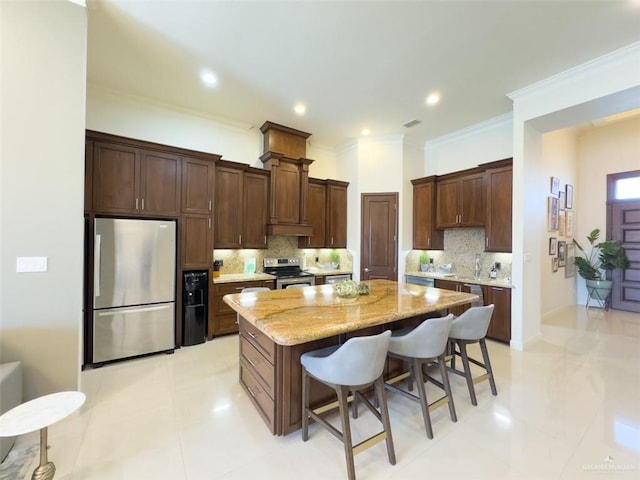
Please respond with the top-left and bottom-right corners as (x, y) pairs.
(610, 201), (640, 313)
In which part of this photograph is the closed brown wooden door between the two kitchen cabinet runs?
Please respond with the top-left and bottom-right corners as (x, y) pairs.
(360, 193), (398, 281)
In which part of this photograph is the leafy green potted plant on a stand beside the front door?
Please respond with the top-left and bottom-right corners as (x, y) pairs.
(573, 228), (629, 308)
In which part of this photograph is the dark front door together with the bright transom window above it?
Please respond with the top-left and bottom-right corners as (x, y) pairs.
(607, 170), (640, 313)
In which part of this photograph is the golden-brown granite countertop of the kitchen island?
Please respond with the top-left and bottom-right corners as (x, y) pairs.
(223, 280), (478, 345)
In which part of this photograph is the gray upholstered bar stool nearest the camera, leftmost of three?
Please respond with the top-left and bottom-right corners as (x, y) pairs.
(300, 330), (396, 480)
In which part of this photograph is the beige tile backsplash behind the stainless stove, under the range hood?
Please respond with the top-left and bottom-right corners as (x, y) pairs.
(213, 236), (353, 274)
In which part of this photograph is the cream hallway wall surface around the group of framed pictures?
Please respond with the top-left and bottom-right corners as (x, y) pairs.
(538, 129), (578, 317)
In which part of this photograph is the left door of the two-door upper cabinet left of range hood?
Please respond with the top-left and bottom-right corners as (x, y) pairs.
(213, 162), (244, 248)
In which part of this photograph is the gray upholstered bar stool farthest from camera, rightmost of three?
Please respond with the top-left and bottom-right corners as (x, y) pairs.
(449, 304), (498, 405)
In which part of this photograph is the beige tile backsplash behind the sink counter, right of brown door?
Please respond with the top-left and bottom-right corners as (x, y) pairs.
(405, 228), (512, 278)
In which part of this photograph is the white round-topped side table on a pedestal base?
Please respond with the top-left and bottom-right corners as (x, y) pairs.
(0, 392), (86, 480)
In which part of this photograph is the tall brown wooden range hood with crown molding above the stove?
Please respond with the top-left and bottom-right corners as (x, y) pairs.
(260, 122), (313, 237)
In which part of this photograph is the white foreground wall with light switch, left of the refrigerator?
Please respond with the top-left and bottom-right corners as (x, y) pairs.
(0, 0), (87, 400)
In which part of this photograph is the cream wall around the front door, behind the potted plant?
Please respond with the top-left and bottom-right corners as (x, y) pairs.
(574, 118), (640, 304)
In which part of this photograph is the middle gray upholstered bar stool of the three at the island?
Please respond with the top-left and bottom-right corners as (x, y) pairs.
(385, 314), (458, 438)
